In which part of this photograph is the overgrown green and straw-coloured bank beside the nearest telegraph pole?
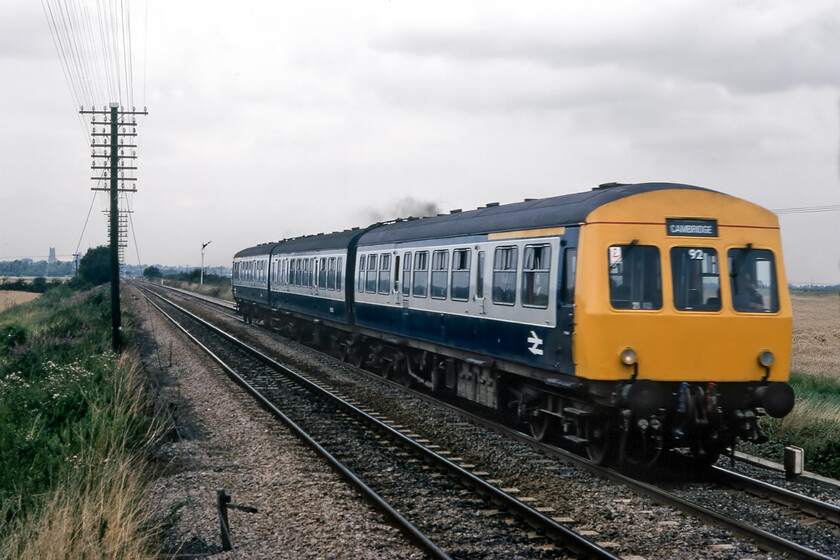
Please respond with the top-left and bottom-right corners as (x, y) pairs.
(0, 286), (155, 560)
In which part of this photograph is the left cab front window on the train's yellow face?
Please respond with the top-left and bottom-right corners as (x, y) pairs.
(607, 243), (662, 309)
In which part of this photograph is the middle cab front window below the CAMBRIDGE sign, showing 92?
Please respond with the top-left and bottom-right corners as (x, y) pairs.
(671, 247), (720, 311)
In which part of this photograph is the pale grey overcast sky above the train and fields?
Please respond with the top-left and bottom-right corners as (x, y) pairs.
(0, 0), (840, 283)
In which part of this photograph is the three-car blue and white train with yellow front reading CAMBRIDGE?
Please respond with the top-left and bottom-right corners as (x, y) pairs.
(233, 183), (794, 465)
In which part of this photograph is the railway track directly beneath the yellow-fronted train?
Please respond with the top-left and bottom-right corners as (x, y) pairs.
(144, 284), (840, 559)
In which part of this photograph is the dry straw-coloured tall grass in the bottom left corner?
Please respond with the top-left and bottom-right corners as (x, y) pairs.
(0, 358), (159, 560)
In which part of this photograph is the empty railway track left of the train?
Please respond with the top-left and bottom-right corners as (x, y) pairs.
(135, 282), (617, 560)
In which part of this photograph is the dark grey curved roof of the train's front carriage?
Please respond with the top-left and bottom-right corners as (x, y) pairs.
(359, 183), (709, 245)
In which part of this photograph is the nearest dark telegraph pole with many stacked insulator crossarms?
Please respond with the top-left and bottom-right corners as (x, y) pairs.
(79, 103), (149, 352)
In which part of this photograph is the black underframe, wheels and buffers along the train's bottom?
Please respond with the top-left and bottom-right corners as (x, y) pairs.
(240, 304), (793, 468)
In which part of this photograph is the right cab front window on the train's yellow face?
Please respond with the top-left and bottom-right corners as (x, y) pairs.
(728, 247), (779, 313)
